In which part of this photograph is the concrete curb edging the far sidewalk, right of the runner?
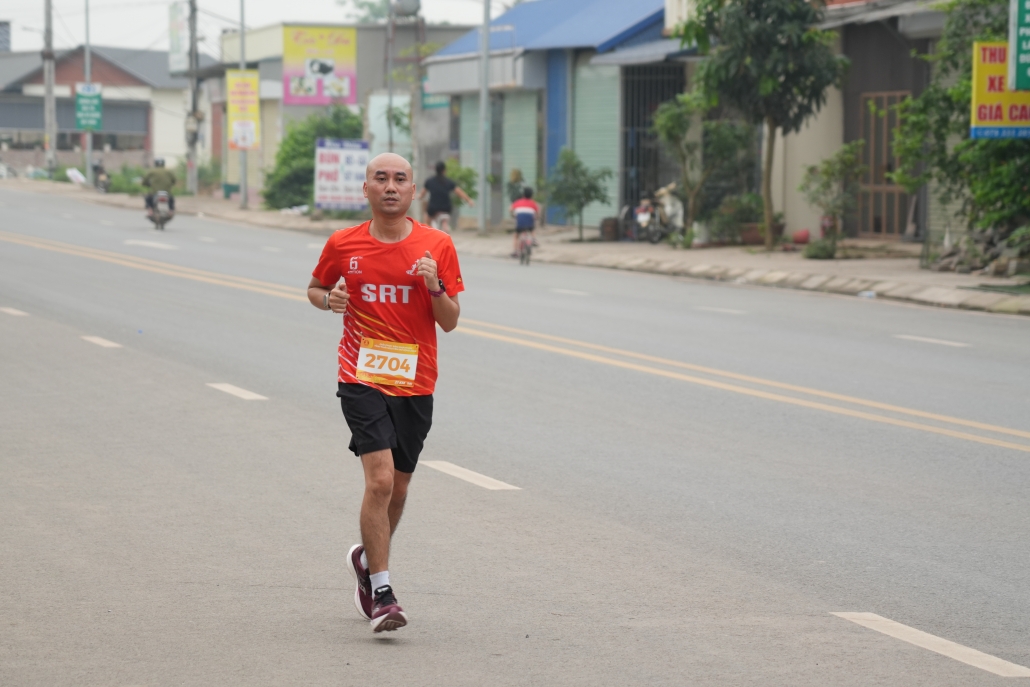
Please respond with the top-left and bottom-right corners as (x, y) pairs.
(458, 246), (1030, 315)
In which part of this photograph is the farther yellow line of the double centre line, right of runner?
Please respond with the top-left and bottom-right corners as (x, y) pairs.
(461, 317), (1030, 439)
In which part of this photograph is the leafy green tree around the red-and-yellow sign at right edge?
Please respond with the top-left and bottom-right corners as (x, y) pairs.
(893, 0), (1030, 262)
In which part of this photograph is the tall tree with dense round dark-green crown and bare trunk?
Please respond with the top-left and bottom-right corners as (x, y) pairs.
(677, 0), (849, 250)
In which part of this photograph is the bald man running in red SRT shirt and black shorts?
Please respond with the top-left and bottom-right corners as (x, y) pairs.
(308, 152), (465, 632)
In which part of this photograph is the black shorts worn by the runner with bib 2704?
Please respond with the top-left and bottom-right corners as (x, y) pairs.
(336, 382), (433, 474)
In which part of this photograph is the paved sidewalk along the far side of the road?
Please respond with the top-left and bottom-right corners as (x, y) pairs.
(8, 179), (1030, 315)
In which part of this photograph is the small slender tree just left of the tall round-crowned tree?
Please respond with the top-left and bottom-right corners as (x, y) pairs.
(651, 91), (752, 243)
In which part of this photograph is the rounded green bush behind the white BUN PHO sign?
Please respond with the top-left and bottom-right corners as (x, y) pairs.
(263, 106), (363, 208)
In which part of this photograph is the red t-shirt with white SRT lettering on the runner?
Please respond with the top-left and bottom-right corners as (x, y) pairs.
(312, 217), (465, 396)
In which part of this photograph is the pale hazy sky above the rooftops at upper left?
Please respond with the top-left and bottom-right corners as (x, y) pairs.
(6, 0), (511, 56)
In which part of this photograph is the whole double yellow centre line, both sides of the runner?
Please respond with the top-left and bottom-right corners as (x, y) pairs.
(0, 232), (1030, 453)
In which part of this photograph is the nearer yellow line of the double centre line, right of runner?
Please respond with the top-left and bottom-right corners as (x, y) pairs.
(457, 325), (1030, 453)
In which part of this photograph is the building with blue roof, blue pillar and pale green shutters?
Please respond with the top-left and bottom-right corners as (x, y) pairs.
(425, 0), (687, 226)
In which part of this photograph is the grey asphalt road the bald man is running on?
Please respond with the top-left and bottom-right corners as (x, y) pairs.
(6, 188), (1030, 687)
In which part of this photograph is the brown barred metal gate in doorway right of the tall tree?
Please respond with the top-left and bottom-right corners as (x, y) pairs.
(858, 91), (915, 240)
